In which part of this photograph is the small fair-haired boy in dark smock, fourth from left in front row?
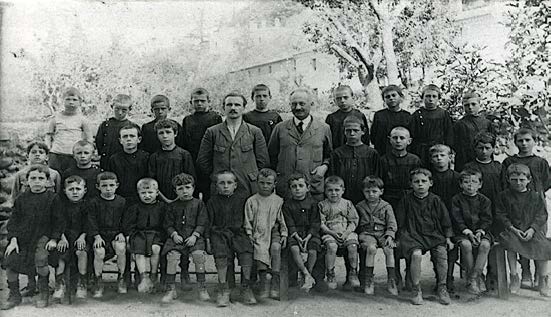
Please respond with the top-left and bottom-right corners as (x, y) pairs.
(123, 178), (167, 293)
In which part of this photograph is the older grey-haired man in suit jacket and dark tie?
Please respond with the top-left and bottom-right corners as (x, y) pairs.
(268, 88), (333, 200)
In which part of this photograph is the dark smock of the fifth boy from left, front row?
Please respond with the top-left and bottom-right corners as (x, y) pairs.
(162, 198), (208, 256)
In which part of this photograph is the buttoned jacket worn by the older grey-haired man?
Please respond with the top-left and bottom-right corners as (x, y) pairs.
(268, 118), (333, 198)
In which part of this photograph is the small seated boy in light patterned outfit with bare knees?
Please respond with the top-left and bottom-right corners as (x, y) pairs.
(318, 176), (360, 289)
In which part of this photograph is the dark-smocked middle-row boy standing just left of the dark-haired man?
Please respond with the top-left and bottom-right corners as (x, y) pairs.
(148, 119), (195, 202)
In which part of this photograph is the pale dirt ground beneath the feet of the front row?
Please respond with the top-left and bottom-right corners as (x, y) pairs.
(0, 252), (551, 317)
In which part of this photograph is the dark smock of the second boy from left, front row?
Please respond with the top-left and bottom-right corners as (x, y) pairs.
(48, 194), (88, 267)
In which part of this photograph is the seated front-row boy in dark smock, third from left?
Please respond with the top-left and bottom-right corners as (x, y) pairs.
(88, 172), (127, 298)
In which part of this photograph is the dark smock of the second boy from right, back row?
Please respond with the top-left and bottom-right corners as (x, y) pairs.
(409, 107), (453, 167)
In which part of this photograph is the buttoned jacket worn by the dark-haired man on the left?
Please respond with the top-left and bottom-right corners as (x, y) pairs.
(197, 121), (270, 197)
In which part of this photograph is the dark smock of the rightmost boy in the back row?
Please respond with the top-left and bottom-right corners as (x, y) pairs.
(453, 115), (494, 172)
